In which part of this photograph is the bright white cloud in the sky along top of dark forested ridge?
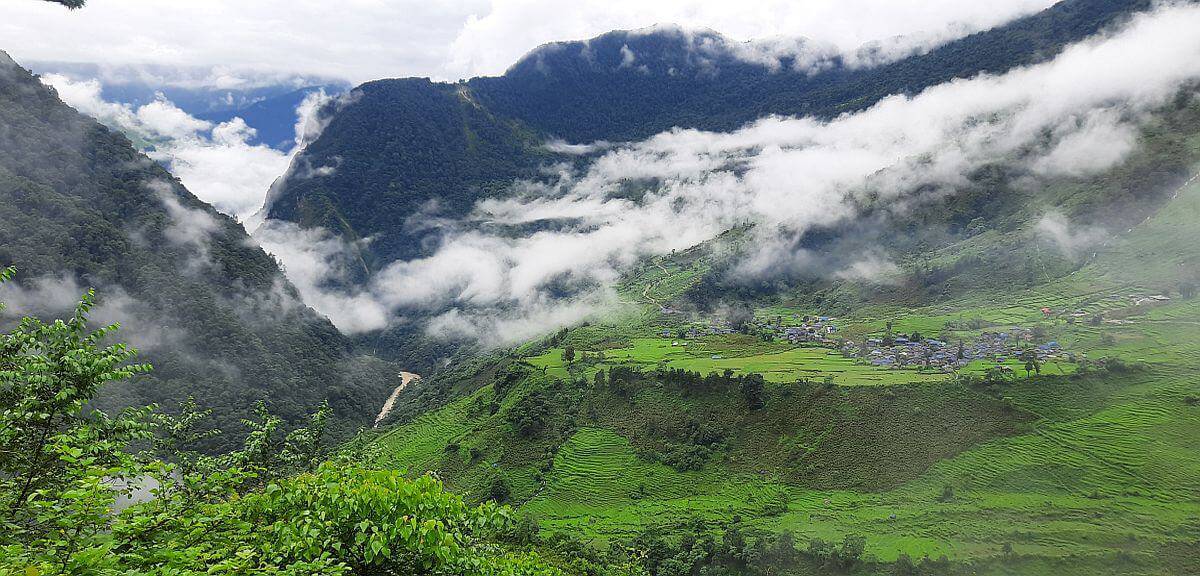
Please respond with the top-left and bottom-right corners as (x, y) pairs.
(444, 0), (1054, 78)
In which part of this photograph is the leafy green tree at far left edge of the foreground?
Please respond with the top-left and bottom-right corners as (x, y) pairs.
(0, 268), (150, 553)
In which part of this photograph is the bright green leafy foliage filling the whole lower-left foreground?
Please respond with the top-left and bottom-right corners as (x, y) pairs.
(0, 286), (563, 576)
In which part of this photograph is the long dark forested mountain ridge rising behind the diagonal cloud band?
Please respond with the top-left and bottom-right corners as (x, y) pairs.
(268, 0), (1152, 269)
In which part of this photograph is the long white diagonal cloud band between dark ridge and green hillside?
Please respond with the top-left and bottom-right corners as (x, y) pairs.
(260, 5), (1200, 342)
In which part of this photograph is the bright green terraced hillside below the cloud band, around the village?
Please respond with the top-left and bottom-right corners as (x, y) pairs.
(374, 107), (1200, 575)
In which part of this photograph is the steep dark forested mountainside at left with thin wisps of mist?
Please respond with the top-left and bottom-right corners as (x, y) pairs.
(0, 54), (398, 451)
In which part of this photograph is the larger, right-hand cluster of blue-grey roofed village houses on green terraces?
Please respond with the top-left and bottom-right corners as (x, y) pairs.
(841, 328), (1074, 372)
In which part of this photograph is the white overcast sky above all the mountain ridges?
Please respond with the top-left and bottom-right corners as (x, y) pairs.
(0, 0), (1054, 83)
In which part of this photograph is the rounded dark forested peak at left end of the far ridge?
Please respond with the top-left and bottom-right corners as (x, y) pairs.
(268, 79), (551, 265)
